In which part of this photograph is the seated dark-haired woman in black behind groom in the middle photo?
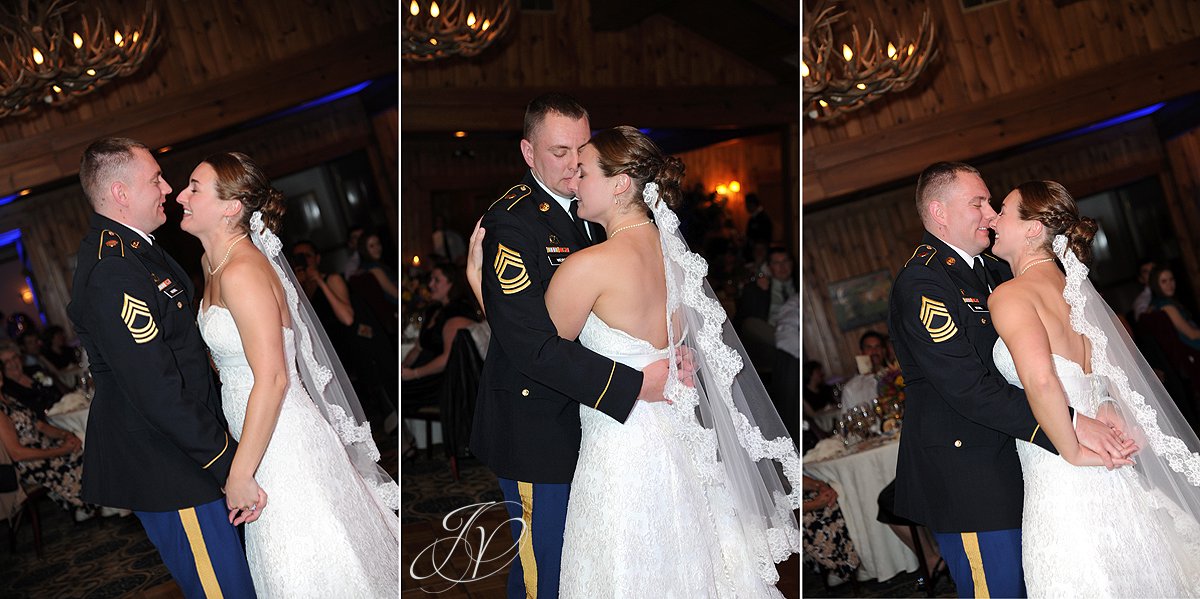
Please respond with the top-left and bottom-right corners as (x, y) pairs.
(400, 262), (481, 455)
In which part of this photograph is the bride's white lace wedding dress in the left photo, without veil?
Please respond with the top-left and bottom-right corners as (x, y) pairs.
(198, 306), (400, 599)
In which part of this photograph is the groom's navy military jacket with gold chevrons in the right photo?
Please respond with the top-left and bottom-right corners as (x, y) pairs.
(888, 233), (1054, 533)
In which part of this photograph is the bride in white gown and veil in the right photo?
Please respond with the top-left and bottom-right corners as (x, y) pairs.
(988, 181), (1200, 598)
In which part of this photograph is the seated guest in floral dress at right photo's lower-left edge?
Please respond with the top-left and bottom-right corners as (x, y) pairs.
(802, 475), (860, 581)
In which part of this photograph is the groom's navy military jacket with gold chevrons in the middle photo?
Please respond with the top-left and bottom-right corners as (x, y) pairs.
(470, 173), (642, 483)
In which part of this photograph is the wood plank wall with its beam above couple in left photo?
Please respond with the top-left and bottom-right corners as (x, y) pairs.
(0, 0), (398, 194)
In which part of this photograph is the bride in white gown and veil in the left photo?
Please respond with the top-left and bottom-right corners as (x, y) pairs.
(178, 152), (398, 599)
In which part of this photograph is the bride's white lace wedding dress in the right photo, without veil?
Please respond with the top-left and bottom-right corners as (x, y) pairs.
(992, 339), (1200, 598)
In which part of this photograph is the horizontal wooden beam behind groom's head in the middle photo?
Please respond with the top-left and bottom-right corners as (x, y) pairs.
(400, 86), (800, 132)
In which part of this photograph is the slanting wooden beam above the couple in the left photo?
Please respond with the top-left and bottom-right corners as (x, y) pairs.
(0, 23), (398, 194)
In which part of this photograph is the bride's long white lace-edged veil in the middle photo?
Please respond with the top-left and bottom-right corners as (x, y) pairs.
(643, 182), (803, 585)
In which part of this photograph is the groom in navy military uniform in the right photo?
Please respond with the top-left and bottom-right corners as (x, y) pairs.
(888, 162), (1129, 597)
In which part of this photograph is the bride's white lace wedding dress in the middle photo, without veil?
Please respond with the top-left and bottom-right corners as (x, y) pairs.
(559, 313), (782, 599)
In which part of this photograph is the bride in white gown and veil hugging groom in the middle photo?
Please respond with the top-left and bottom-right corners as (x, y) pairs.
(468, 127), (802, 598)
